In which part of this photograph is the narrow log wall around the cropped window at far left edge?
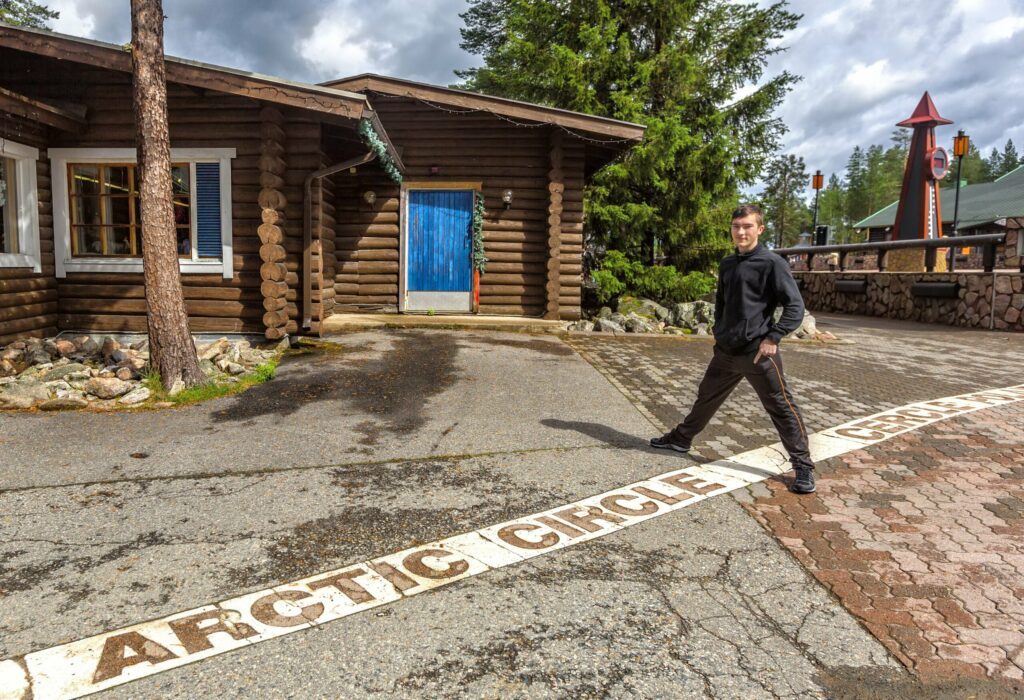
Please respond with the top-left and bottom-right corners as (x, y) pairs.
(0, 112), (57, 345)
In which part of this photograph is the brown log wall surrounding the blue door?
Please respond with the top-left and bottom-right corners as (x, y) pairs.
(334, 93), (584, 318)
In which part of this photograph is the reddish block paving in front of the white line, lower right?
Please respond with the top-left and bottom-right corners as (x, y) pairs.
(745, 403), (1024, 692)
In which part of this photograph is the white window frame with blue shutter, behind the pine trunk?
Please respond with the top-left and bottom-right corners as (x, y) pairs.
(49, 148), (236, 279)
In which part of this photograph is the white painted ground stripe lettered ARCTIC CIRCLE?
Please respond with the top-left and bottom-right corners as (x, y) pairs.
(8, 385), (1024, 700)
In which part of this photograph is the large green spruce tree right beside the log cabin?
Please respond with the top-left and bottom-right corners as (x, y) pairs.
(459, 0), (800, 269)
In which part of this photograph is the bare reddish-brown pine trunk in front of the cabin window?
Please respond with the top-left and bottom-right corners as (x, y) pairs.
(131, 0), (205, 389)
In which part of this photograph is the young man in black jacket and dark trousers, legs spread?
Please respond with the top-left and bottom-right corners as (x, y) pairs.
(650, 205), (814, 493)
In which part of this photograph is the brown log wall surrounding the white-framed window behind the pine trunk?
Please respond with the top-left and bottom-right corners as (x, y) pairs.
(47, 70), (265, 333)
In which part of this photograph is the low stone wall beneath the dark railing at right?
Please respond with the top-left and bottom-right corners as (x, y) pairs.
(794, 270), (1024, 332)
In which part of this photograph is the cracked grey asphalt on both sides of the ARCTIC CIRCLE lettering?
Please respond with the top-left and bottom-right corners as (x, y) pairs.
(0, 331), (978, 698)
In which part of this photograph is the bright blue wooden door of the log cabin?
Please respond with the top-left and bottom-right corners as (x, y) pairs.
(407, 189), (473, 293)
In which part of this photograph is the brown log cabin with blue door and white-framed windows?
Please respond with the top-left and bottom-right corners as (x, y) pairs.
(0, 24), (643, 345)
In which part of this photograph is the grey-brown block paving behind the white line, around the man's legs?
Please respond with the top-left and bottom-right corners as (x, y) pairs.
(568, 317), (1024, 460)
